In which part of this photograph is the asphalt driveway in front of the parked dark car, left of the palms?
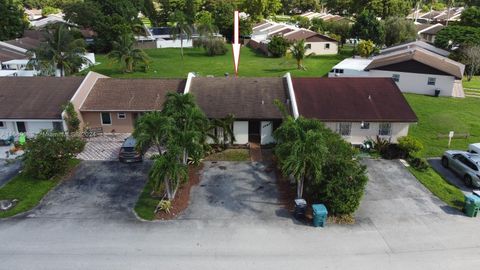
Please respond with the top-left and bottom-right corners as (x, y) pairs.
(26, 161), (150, 221)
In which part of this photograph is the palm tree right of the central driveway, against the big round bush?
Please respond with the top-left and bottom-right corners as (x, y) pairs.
(274, 117), (328, 198)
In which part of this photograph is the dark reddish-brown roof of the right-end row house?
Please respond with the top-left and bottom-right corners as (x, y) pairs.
(292, 78), (417, 122)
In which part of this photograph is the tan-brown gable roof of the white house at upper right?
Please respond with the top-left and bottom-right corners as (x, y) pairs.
(365, 48), (465, 79)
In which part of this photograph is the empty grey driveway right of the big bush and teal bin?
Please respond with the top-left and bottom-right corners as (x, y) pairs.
(356, 159), (454, 228)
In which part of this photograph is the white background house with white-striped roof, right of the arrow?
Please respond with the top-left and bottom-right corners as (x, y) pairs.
(248, 21), (338, 55)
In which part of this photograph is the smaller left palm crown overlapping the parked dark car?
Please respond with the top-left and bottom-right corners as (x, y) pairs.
(133, 111), (175, 154)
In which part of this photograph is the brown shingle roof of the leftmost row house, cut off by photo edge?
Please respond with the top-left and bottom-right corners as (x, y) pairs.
(0, 77), (84, 119)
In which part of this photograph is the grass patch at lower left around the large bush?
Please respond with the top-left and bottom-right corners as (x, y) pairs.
(0, 159), (80, 218)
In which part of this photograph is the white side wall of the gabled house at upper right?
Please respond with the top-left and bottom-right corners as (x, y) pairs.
(369, 70), (456, 97)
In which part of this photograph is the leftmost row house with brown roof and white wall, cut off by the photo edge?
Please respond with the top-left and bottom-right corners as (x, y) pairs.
(0, 77), (84, 139)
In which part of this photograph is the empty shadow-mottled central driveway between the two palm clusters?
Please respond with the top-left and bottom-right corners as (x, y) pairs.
(179, 162), (286, 222)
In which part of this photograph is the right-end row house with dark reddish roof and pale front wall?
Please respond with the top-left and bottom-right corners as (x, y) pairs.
(292, 78), (418, 145)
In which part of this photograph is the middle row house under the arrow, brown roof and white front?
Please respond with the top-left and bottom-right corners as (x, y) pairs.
(185, 77), (289, 145)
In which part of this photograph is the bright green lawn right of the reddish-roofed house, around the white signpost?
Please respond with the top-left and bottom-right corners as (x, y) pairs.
(405, 94), (480, 157)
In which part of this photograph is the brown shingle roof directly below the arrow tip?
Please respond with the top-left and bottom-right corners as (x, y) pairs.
(190, 77), (287, 119)
